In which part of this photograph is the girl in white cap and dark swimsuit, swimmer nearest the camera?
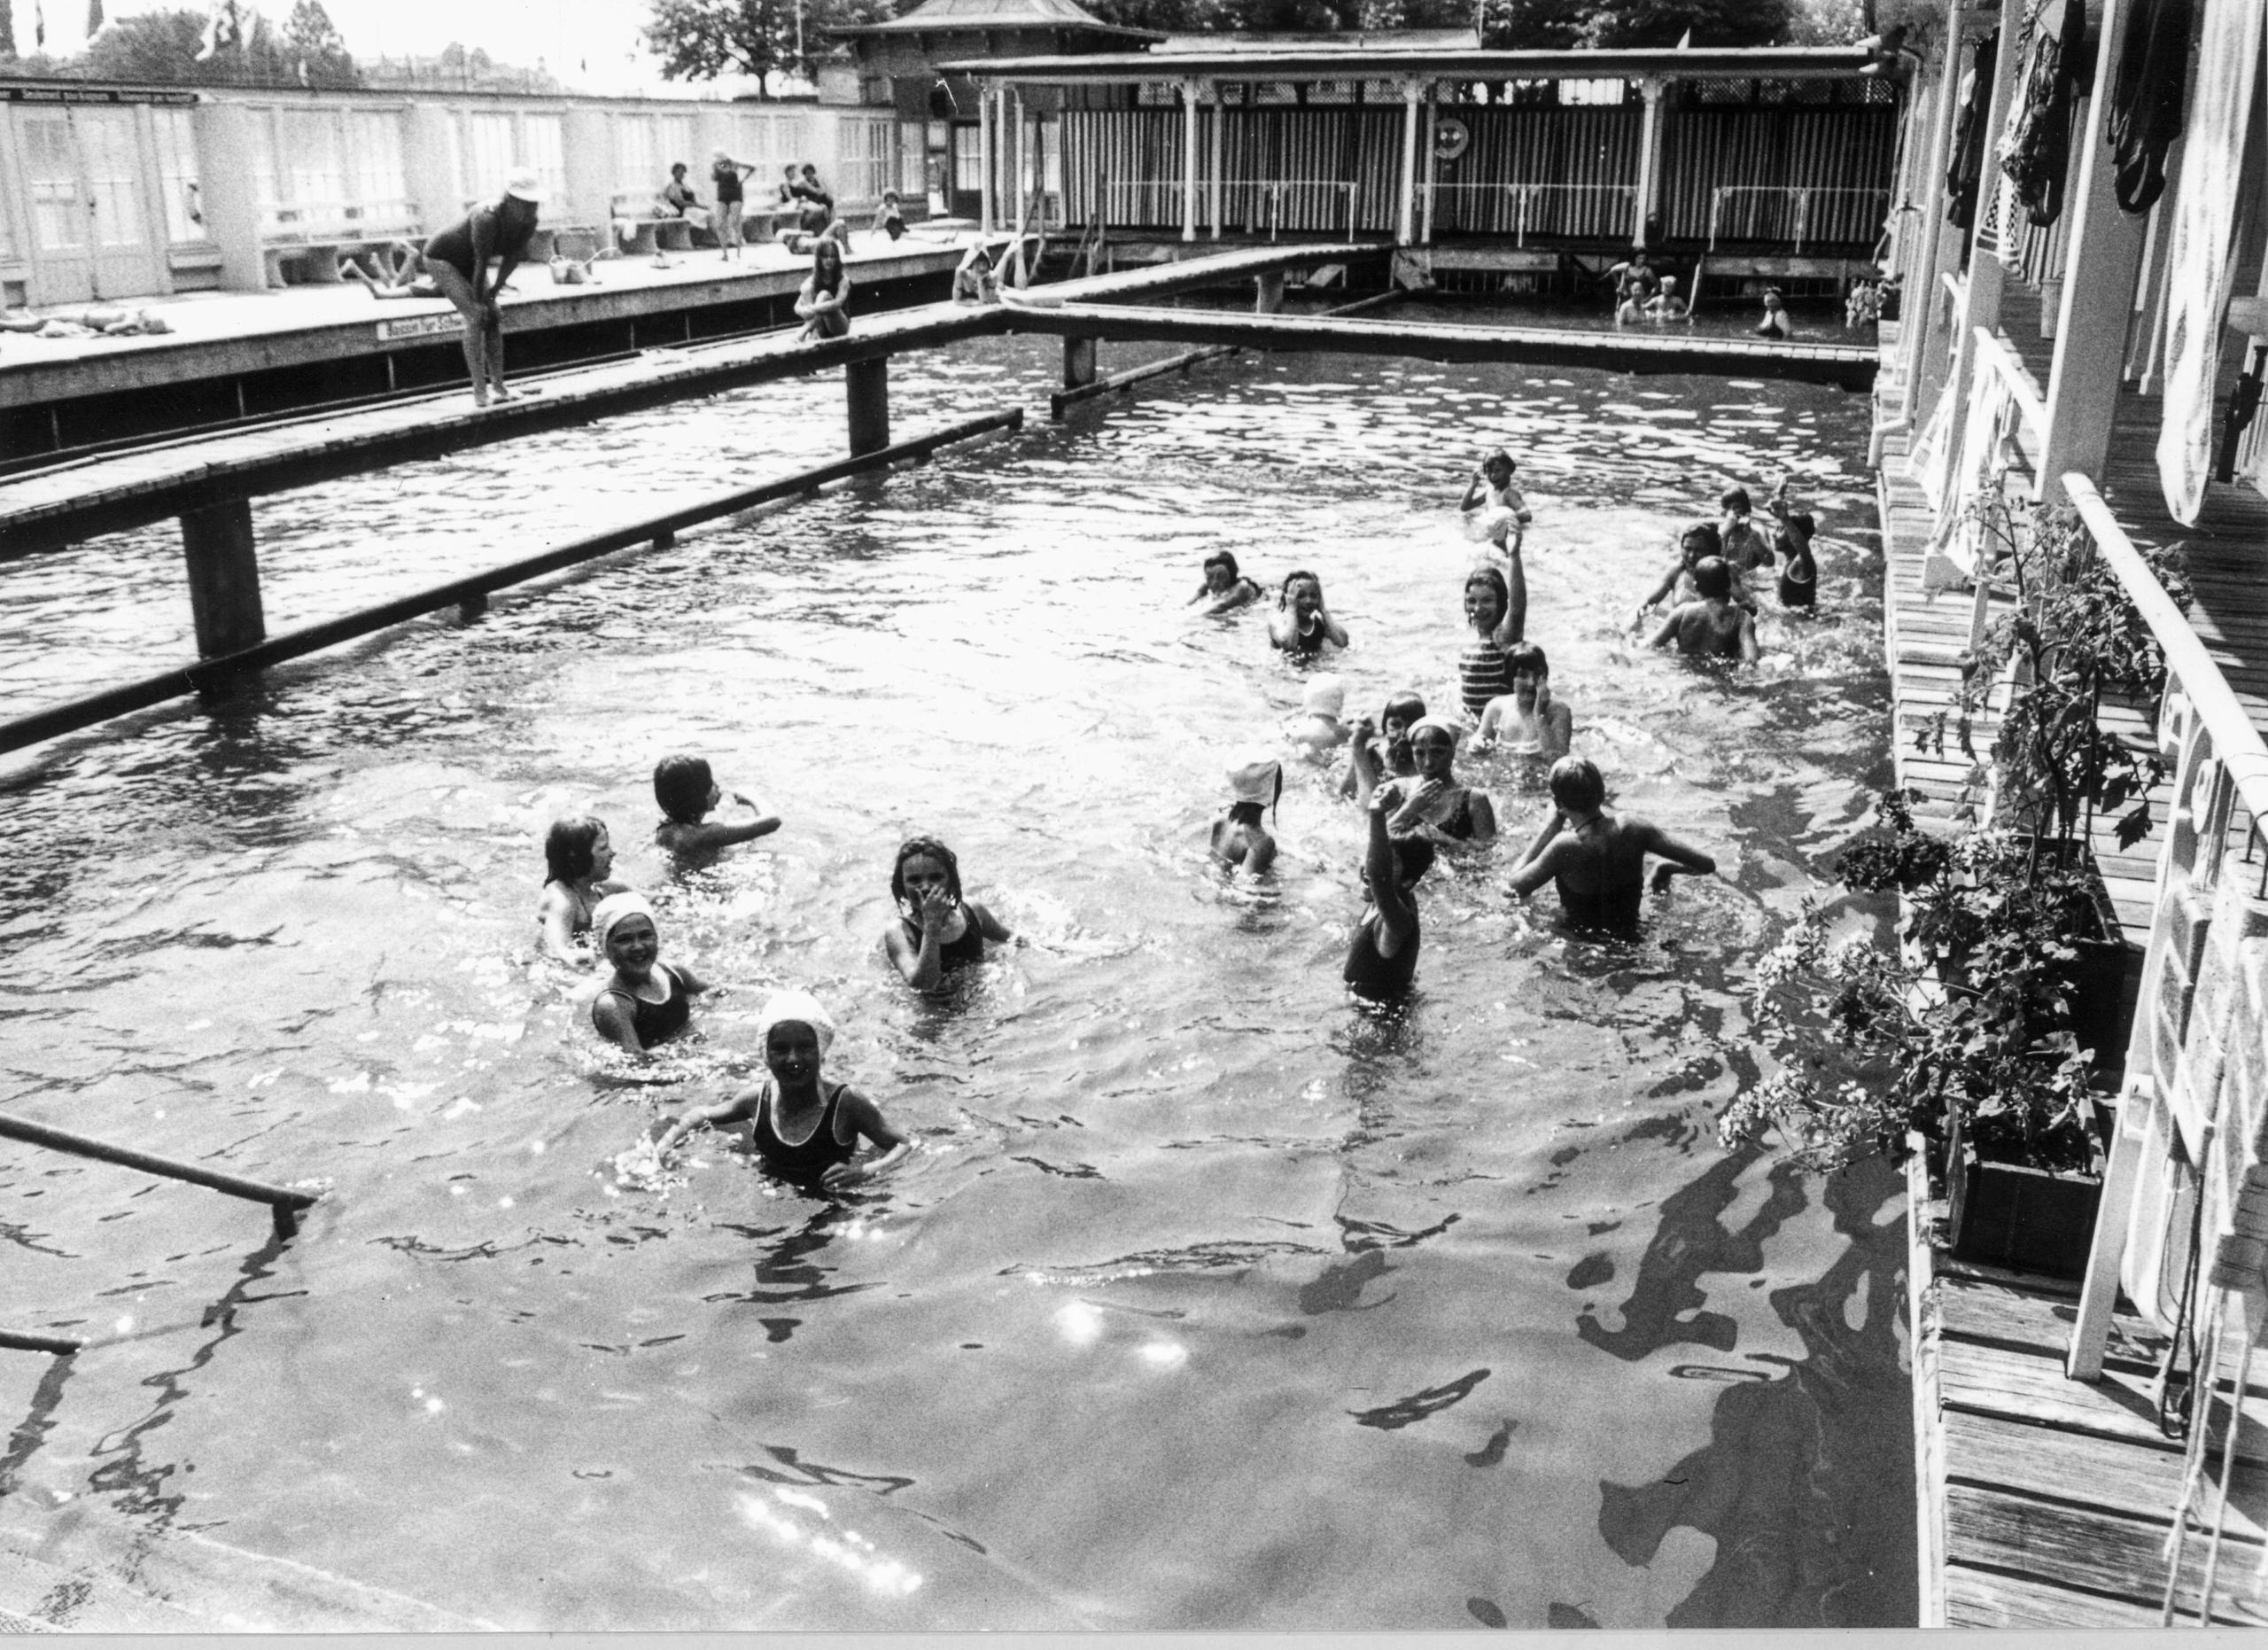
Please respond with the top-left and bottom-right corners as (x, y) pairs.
(653, 992), (914, 1189)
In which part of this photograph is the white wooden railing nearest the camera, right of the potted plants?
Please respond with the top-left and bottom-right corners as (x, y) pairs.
(2064, 474), (2268, 1621)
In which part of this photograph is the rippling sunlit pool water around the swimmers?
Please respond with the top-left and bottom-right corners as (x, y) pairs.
(0, 315), (1915, 1630)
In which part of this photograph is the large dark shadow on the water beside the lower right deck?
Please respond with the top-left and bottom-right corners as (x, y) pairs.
(1576, 1153), (1916, 1627)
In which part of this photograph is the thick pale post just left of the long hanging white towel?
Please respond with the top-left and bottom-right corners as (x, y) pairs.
(2039, 0), (2148, 504)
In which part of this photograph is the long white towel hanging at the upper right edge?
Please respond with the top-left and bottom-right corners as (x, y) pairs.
(2157, 0), (2268, 526)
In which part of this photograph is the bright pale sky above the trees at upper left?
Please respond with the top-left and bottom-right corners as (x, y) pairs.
(13, 0), (703, 90)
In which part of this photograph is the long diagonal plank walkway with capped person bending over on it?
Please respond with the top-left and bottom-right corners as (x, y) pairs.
(0, 245), (1386, 561)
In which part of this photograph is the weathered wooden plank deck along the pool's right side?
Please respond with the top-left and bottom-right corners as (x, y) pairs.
(1880, 288), (2268, 1630)
